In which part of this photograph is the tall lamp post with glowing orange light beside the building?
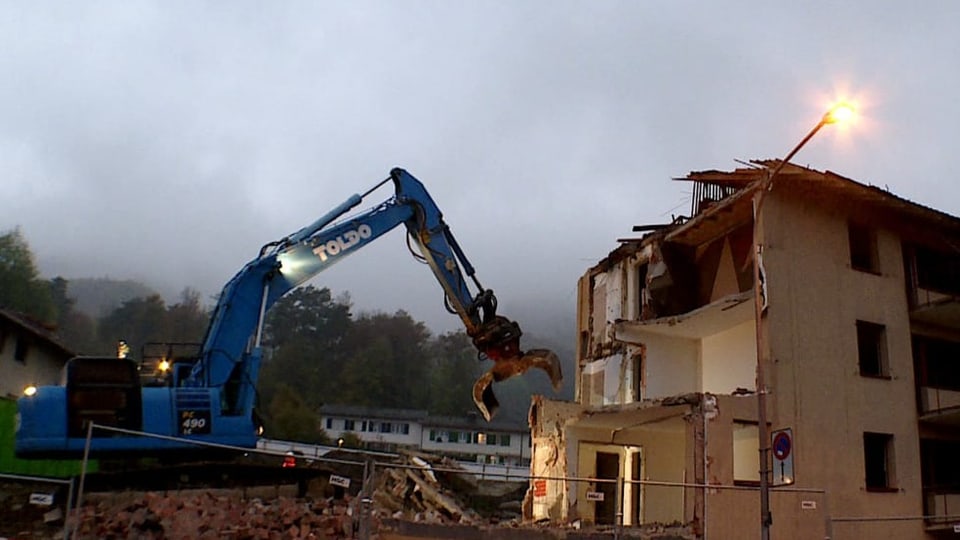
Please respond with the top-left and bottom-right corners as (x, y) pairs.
(753, 103), (853, 540)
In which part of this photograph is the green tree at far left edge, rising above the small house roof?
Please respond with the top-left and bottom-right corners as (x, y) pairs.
(0, 229), (57, 324)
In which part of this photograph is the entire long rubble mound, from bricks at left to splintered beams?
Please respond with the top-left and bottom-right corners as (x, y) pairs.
(0, 454), (526, 540)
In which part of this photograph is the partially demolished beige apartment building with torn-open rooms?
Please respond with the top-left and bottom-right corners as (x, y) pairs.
(527, 161), (960, 539)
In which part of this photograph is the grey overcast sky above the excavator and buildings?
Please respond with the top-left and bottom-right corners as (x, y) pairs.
(0, 0), (960, 330)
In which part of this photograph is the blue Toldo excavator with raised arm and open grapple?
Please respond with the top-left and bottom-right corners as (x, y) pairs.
(15, 168), (562, 458)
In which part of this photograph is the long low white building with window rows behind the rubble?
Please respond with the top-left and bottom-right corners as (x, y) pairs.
(320, 405), (530, 465)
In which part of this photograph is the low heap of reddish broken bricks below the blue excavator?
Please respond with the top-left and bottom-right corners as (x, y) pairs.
(71, 491), (354, 540)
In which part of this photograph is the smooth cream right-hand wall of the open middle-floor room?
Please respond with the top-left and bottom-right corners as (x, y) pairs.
(700, 320), (757, 394)
